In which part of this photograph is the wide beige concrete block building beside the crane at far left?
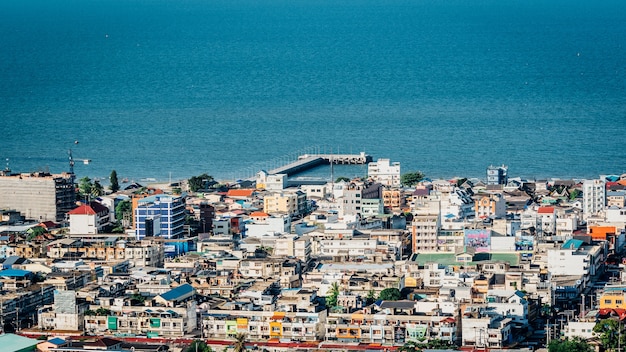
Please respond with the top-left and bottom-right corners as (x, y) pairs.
(0, 172), (76, 221)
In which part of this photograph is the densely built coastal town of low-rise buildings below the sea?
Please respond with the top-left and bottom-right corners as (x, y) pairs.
(0, 153), (626, 352)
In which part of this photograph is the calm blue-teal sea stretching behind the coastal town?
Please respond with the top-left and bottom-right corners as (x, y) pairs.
(0, 0), (626, 183)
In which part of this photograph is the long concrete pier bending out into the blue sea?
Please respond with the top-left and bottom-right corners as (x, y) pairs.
(241, 152), (372, 181)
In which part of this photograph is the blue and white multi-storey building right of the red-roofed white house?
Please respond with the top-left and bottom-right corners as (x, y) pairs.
(133, 194), (185, 239)
